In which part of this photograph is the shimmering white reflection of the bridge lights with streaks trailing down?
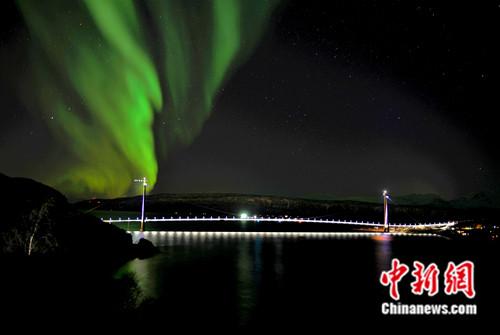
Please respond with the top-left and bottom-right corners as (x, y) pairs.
(122, 231), (435, 302)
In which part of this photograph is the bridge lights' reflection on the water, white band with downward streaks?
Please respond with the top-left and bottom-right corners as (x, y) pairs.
(123, 231), (437, 300)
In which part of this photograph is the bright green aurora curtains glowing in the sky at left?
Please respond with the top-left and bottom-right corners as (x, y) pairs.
(18, 0), (276, 198)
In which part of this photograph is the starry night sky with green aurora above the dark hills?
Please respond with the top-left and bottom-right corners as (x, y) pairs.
(0, 0), (500, 198)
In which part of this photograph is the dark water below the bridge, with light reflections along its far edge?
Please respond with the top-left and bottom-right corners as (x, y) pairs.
(118, 232), (499, 330)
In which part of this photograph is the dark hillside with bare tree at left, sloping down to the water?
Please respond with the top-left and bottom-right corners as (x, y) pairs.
(0, 174), (151, 264)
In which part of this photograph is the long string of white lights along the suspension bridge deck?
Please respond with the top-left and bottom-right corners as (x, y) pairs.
(101, 216), (458, 228)
